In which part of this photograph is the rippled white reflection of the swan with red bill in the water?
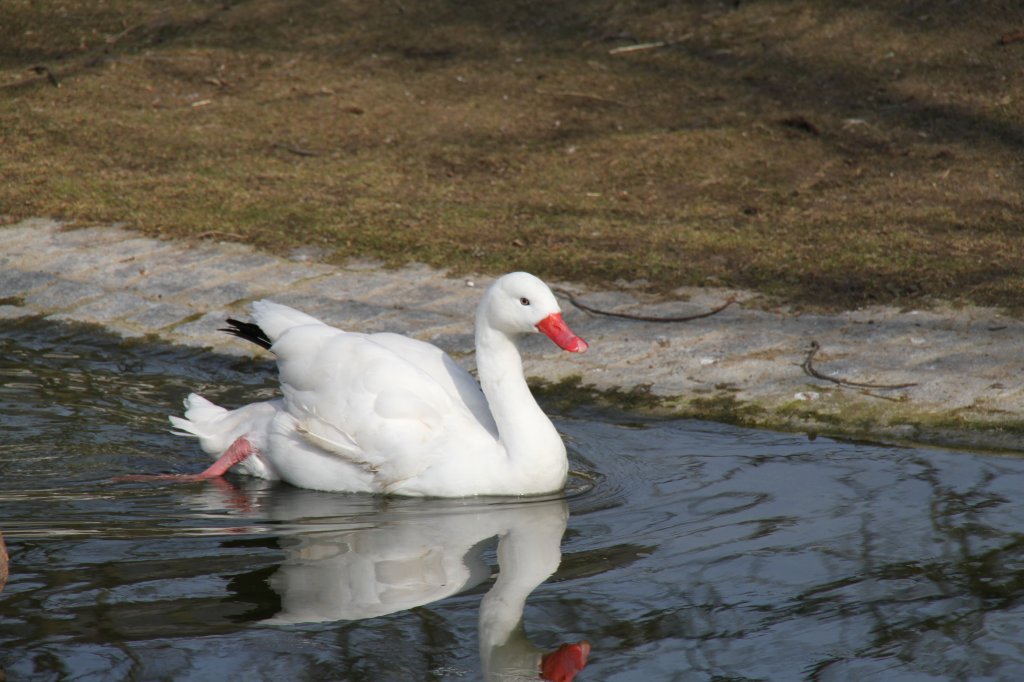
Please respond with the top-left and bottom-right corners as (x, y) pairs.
(251, 491), (590, 681)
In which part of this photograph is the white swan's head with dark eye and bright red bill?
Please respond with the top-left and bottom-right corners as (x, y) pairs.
(478, 272), (587, 353)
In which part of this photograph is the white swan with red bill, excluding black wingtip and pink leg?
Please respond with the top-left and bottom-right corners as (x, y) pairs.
(171, 272), (587, 497)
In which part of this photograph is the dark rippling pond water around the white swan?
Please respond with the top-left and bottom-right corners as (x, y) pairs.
(0, 322), (1024, 681)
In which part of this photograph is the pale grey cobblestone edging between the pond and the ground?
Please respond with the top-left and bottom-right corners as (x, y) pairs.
(0, 219), (1024, 449)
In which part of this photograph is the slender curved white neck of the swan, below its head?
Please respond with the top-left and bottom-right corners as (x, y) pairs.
(476, 324), (568, 485)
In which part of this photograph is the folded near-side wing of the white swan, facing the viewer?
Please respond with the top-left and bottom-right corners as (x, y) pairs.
(273, 325), (484, 489)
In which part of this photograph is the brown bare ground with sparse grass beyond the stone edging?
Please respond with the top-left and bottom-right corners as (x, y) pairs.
(0, 0), (1024, 310)
